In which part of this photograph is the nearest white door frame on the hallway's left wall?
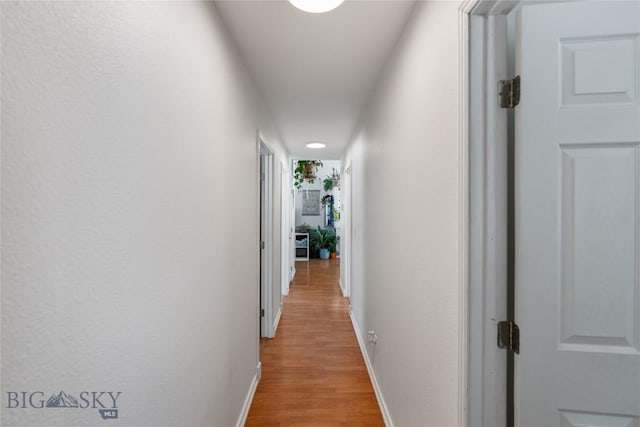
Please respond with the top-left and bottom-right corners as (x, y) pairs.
(257, 131), (275, 338)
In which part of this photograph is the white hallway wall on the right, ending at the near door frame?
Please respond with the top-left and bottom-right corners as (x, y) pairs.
(343, 1), (462, 426)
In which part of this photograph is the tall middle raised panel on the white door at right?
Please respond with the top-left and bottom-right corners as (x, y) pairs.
(559, 144), (640, 353)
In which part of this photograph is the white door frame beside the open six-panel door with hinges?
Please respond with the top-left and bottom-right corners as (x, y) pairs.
(460, 0), (522, 427)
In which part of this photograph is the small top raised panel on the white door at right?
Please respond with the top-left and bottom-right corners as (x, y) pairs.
(561, 35), (640, 105)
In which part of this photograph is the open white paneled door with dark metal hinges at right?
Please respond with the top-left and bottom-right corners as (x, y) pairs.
(515, 1), (640, 427)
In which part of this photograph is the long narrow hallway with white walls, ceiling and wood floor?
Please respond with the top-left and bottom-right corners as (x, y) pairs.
(0, 0), (464, 427)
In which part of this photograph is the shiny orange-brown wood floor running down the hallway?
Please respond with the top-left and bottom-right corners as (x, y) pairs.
(246, 260), (384, 427)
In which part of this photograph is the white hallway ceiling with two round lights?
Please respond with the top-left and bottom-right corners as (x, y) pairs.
(216, 0), (415, 159)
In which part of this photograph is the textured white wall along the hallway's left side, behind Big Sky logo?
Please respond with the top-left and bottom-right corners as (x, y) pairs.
(1, 2), (286, 427)
